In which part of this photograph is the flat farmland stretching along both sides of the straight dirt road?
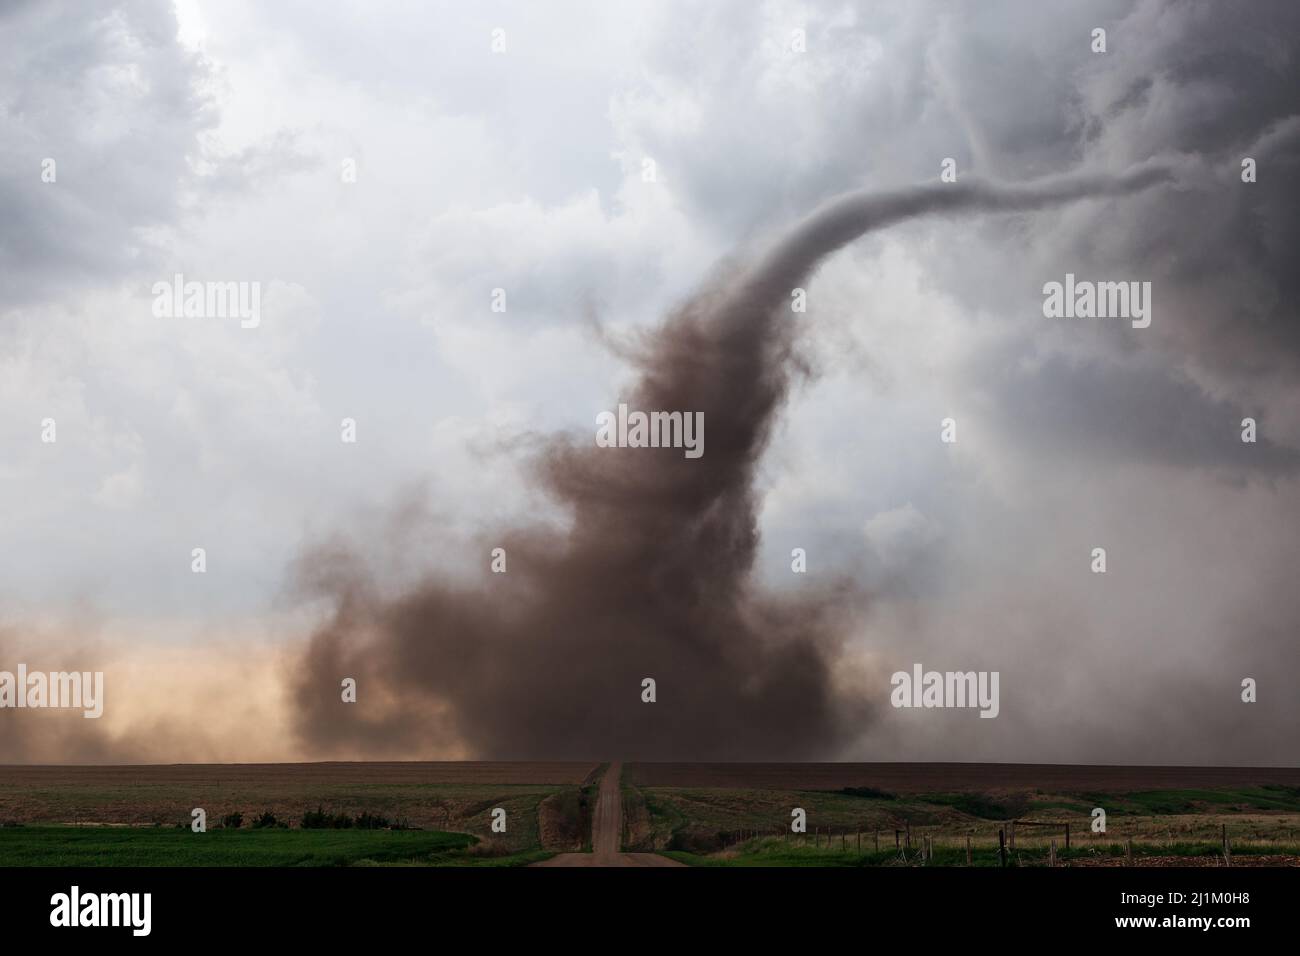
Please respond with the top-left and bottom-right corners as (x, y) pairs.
(0, 762), (1300, 866)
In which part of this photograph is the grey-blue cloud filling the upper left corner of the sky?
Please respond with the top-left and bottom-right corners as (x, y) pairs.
(0, 0), (213, 310)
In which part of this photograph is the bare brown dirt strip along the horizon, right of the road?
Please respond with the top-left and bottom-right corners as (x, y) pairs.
(625, 763), (1300, 793)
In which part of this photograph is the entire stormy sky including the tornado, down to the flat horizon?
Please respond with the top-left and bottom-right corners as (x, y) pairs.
(0, 1), (1300, 765)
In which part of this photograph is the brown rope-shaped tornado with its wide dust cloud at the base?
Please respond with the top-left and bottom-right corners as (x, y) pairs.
(295, 166), (1170, 760)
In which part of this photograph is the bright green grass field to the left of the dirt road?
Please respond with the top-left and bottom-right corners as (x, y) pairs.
(0, 826), (551, 866)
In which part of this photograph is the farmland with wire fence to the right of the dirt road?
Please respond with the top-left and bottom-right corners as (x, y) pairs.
(624, 763), (1300, 866)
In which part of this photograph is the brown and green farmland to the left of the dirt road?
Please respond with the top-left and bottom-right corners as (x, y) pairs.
(0, 762), (599, 865)
